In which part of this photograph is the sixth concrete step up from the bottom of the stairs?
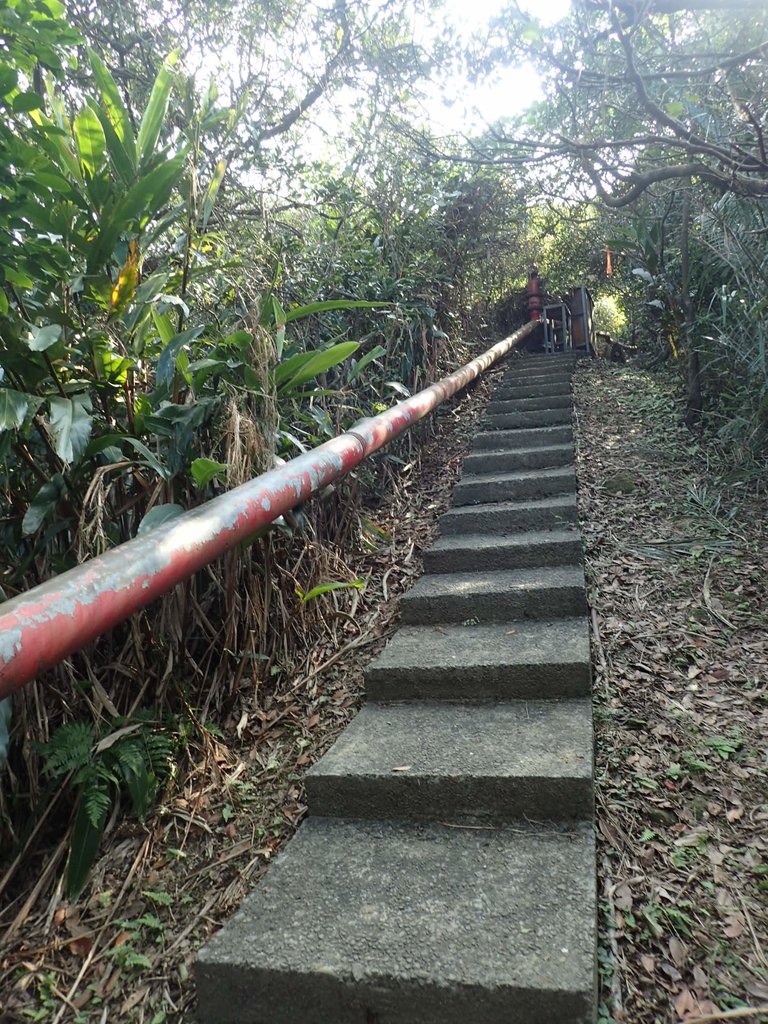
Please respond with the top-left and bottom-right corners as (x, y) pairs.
(440, 492), (579, 536)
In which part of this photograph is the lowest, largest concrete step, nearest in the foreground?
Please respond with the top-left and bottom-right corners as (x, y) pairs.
(195, 818), (596, 1024)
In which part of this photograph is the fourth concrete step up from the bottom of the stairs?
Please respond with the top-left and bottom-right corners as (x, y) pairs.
(400, 565), (587, 626)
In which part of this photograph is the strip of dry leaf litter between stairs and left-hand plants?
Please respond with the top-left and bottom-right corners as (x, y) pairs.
(0, 356), (496, 1024)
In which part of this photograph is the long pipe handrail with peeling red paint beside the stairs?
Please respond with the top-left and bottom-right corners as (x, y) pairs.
(0, 322), (539, 698)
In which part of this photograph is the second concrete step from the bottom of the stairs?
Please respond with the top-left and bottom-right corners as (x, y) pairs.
(305, 700), (594, 824)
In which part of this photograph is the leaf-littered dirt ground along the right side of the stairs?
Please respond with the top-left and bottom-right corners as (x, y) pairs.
(574, 364), (768, 1024)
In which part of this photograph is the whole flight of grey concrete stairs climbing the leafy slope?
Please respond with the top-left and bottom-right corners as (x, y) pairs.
(196, 353), (596, 1024)
